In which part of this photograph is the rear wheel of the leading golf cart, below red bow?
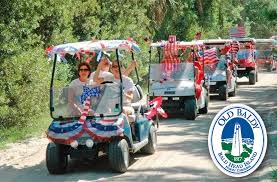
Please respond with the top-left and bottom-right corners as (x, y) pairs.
(141, 125), (157, 154)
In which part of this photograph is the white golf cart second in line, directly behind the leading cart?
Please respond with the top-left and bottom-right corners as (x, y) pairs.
(148, 36), (206, 120)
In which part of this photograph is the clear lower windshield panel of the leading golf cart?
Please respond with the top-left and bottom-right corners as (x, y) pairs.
(52, 83), (121, 119)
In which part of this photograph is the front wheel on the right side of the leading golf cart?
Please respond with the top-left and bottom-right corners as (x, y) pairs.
(108, 139), (129, 173)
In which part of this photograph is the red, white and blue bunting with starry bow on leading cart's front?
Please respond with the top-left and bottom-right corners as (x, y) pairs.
(47, 86), (126, 144)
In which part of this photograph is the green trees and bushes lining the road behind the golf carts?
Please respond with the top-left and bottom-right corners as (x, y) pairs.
(0, 0), (277, 127)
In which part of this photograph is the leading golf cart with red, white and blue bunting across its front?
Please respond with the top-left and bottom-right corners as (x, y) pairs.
(46, 40), (157, 174)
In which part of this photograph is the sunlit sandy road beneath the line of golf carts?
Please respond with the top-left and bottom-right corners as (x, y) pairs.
(0, 73), (277, 182)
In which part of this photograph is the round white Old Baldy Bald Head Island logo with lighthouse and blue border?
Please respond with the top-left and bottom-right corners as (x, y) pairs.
(208, 104), (267, 177)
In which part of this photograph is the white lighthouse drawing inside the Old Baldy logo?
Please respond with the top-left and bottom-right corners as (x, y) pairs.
(231, 123), (243, 156)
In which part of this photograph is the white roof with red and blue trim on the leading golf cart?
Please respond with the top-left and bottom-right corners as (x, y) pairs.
(49, 40), (140, 55)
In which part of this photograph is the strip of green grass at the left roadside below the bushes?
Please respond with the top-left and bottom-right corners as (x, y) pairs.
(0, 114), (51, 149)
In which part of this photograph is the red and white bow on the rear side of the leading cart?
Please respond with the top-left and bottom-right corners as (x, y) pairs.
(144, 96), (168, 120)
